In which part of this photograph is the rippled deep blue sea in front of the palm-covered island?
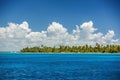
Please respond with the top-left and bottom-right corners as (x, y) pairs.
(0, 53), (120, 80)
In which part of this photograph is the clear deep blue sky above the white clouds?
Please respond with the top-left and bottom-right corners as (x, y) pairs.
(0, 0), (120, 37)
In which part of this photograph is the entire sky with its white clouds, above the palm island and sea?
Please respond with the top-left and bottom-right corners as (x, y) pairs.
(0, 0), (120, 51)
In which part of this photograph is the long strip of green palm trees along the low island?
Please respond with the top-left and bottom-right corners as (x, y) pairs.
(21, 43), (120, 53)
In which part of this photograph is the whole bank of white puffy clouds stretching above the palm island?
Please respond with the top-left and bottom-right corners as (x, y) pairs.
(0, 21), (120, 51)
